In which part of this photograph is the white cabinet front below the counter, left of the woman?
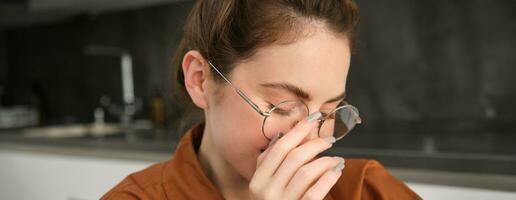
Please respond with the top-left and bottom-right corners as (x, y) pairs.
(0, 149), (152, 200)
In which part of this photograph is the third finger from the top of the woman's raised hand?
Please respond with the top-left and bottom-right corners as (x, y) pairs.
(285, 157), (344, 199)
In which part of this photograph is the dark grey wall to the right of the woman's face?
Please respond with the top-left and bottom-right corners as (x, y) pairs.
(348, 0), (516, 134)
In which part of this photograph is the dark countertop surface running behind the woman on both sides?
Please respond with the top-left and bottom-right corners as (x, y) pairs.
(0, 122), (516, 175)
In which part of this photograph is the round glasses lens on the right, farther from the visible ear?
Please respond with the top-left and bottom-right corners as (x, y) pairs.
(319, 105), (361, 140)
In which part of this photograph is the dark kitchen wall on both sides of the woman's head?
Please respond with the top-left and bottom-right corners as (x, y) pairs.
(0, 0), (516, 133)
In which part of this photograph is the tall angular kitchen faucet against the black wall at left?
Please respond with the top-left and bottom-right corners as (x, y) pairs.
(84, 45), (138, 129)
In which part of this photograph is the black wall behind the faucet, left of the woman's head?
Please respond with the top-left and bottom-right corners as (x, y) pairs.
(0, 2), (192, 123)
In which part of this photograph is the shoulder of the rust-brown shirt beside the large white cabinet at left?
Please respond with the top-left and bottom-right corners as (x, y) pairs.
(101, 162), (165, 200)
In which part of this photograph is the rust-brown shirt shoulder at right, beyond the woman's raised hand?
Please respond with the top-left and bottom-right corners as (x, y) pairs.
(331, 159), (421, 199)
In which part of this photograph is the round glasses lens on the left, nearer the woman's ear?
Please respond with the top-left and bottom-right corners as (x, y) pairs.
(263, 101), (308, 139)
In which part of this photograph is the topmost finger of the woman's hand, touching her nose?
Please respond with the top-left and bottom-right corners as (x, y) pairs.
(255, 112), (321, 180)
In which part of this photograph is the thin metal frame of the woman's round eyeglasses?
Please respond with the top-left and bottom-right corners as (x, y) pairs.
(208, 61), (362, 141)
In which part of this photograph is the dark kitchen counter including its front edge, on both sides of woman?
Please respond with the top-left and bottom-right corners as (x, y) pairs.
(0, 125), (516, 191)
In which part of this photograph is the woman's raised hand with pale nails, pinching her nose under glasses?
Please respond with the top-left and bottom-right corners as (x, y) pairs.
(249, 112), (344, 200)
